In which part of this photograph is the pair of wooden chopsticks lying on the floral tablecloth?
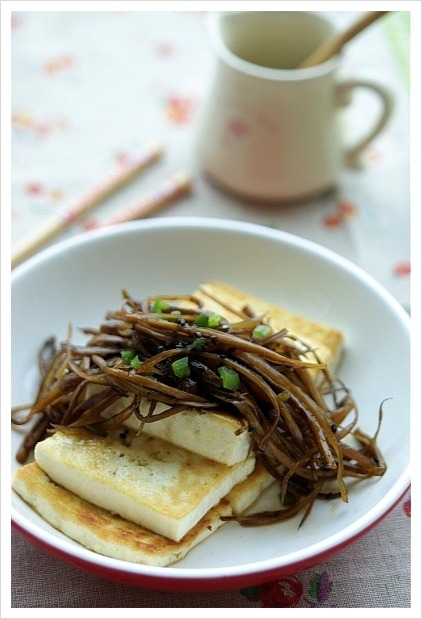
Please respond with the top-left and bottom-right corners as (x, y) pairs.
(11, 143), (192, 269)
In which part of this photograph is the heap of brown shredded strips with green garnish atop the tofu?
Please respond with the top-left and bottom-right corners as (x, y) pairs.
(12, 290), (386, 526)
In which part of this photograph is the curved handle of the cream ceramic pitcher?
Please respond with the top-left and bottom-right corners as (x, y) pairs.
(336, 79), (394, 169)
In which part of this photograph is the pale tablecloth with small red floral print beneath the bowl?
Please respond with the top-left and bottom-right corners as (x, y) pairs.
(8, 3), (413, 617)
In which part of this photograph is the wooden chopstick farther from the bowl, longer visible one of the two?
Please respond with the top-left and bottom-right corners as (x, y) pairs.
(11, 142), (163, 269)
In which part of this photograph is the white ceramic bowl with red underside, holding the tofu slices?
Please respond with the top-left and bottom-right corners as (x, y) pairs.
(11, 217), (410, 591)
